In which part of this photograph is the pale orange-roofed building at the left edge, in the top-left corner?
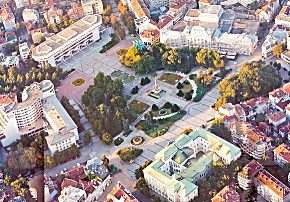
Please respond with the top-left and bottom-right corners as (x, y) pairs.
(0, 3), (15, 31)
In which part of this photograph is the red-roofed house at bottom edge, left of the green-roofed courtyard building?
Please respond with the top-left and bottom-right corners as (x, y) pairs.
(106, 181), (139, 202)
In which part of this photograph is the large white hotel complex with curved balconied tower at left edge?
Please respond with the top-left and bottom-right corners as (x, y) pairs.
(0, 80), (79, 154)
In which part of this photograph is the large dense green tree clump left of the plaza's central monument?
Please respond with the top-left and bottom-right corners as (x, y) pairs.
(82, 72), (132, 144)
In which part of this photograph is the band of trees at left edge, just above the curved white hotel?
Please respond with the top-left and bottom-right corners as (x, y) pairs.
(0, 64), (66, 93)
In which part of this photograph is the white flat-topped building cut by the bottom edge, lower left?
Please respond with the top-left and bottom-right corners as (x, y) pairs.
(58, 186), (87, 202)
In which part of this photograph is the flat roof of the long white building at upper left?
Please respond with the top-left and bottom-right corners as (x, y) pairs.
(32, 15), (102, 56)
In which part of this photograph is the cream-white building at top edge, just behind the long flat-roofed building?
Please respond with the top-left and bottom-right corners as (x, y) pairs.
(81, 0), (103, 15)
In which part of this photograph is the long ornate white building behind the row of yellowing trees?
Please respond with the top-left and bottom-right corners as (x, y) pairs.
(160, 25), (258, 55)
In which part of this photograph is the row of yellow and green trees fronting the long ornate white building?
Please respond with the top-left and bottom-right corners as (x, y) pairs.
(117, 43), (224, 74)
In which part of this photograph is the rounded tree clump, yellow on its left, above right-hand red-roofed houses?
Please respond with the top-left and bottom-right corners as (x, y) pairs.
(215, 60), (282, 109)
